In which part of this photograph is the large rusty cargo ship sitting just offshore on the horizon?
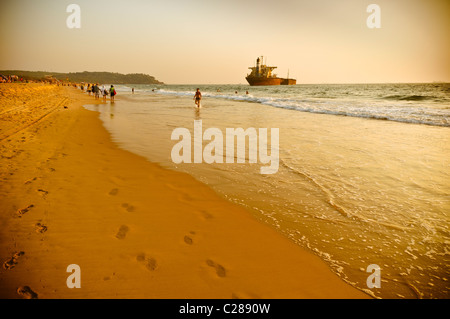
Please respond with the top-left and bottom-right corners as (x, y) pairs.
(245, 57), (297, 86)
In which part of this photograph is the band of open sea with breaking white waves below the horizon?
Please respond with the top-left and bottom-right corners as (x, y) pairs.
(132, 83), (450, 127)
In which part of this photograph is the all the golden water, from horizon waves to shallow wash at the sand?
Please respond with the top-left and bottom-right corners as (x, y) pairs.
(87, 83), (450, 298)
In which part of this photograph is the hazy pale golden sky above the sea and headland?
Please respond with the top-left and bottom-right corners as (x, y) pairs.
(0, 0), (450, 84)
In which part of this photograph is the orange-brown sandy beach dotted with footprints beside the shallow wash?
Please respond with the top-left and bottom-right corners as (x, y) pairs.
(0, 84), (368, 298)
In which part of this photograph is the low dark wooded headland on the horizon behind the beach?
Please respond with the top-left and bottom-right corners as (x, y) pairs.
(0, 70), (164, 84)
